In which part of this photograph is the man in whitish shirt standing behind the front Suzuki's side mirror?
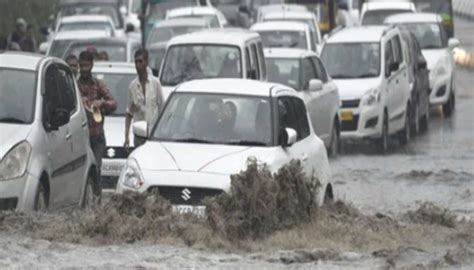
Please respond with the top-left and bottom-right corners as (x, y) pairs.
(124, 49), (164, 148)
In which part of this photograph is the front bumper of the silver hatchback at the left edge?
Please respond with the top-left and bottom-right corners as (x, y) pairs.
(0, 172), (39, 211)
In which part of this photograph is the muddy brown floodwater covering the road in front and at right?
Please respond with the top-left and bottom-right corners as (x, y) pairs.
(0, 17), (474, 269)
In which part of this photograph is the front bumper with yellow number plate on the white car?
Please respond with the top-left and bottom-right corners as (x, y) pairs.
(340, 106), (383, 140)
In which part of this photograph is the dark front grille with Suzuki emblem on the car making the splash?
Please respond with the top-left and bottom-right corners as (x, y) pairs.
(148, 186), (224, 205)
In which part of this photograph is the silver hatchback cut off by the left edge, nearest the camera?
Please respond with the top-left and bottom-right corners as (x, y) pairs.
(0, 52), (100, 210)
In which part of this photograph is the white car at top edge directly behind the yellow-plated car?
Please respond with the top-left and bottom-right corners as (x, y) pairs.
(360, 0), (416, 25)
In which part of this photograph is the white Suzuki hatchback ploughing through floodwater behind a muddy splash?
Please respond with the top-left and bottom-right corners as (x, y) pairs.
(117, 79), (334, 214)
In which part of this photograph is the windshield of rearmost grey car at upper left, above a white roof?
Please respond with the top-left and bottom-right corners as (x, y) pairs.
(58, 3), (121, 28)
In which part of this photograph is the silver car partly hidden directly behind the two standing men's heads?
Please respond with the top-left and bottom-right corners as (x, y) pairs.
(62, 38), (142, 63)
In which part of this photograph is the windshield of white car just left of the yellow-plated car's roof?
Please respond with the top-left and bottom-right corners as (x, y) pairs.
(258, 30), (310, 49)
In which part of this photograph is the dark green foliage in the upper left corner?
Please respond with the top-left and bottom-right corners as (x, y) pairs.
(0, 0), (56, 41)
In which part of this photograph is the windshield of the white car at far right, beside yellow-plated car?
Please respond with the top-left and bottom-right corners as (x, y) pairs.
(405, 23), (444, 49)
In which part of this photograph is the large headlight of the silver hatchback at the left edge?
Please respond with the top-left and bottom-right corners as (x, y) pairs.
(0, 141), (31, 181)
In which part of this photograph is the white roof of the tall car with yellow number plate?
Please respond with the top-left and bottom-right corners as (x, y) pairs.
(326, 25), (391, 43)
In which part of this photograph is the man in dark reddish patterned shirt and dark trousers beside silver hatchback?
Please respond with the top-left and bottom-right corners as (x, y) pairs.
(77, 51), (117, 195)
